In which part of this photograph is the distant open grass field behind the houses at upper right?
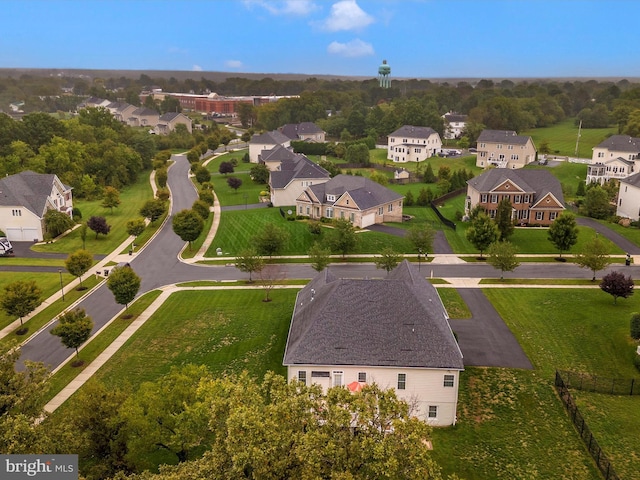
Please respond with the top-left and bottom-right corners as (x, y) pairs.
(518, 118), (617, 158)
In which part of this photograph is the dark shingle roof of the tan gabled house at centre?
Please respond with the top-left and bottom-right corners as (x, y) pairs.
(309, 174), (403, 210)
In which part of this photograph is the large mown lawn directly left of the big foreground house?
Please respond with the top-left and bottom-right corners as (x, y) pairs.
(89, 288), (298, 386)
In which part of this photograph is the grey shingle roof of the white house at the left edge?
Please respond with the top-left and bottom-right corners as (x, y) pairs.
(0, 170), (71, 218)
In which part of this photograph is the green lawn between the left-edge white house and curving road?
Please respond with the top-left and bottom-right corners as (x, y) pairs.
(33, 172), (159, 255)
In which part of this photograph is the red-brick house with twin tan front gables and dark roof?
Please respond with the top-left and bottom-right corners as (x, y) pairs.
(465, 168), (565, 225)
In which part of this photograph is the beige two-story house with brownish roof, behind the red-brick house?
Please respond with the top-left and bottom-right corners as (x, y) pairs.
(476, 130), (536, 169)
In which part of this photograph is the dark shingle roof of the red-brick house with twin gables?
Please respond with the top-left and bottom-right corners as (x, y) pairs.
(467, 168), (564, 204)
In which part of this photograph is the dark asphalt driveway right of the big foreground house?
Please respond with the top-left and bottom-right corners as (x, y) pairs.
(450, 288), (533, 369)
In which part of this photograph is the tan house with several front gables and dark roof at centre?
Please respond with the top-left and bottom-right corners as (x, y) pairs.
(296, 175), (404, 228)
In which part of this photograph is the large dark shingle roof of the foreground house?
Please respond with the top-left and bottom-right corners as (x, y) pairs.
(283, 260), (464, 370)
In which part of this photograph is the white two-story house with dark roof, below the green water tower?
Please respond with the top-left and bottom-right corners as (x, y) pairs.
(387, 125), (442, 163)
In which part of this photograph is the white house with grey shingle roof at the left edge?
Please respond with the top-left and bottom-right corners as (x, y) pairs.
(0, 171), (73, 242)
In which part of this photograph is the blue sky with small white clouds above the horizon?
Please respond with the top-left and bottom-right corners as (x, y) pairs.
(0, 0), (640, 79)
